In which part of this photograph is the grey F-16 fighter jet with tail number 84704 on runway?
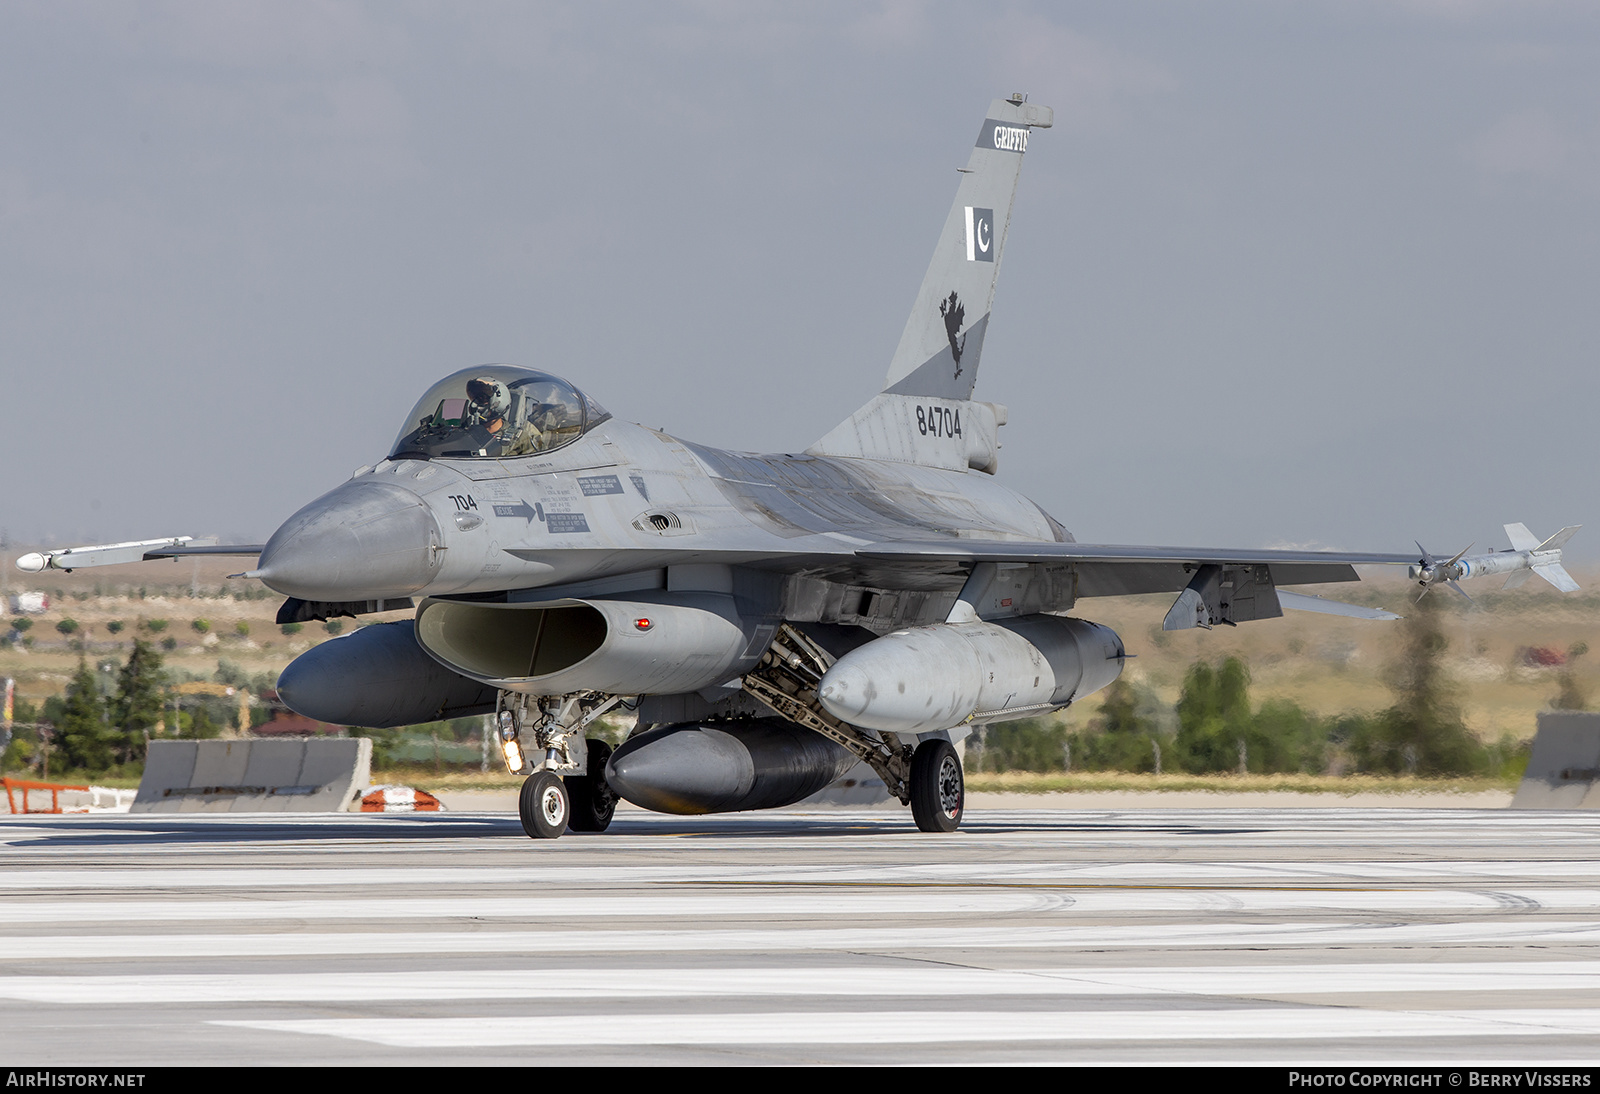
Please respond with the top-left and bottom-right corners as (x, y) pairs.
(24, 94), (1571, 838)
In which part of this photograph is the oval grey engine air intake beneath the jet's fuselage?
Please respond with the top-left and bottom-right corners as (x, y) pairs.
(416, 592), (762, 696)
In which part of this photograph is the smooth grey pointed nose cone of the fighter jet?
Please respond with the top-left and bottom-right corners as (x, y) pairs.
(256, 481), (445, 601)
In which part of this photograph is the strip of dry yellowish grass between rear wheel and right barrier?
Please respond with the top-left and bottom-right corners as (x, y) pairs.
(966, 771), (1517, 795)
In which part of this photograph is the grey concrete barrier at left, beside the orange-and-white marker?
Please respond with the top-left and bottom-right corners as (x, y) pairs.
(131, 737), (373, 813)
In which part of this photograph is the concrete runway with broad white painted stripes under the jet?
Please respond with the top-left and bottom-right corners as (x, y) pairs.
(0, 809), (1600, 1067)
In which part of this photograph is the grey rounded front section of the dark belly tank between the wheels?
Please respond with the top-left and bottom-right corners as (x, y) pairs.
(605, 726), (755, 813)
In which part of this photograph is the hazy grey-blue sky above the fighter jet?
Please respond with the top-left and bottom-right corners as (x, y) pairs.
(0, 0), (1600, 560)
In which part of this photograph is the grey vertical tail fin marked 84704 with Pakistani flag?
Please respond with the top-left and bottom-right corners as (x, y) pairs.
(806, 94), (1054, 473)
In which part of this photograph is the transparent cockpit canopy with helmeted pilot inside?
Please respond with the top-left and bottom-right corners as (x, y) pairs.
(389, 365), (611, 459)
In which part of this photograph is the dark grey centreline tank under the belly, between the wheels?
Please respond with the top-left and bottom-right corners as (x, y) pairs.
(605, 718), (856, 814)
